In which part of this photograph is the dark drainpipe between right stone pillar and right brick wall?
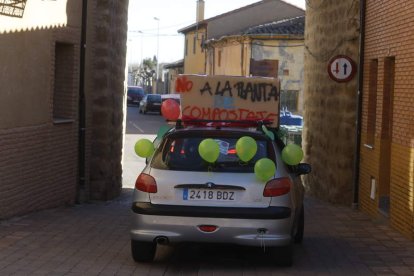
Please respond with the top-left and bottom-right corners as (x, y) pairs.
(352, 0), (366, 209)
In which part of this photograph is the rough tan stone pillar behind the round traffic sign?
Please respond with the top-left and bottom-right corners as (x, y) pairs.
(303, 0), (359, 204)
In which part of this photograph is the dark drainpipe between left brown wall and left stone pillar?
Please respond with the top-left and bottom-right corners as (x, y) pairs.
(76, 0), (88, 203)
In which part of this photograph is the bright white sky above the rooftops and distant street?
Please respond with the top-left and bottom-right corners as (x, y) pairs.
(127, 0), (305, 64)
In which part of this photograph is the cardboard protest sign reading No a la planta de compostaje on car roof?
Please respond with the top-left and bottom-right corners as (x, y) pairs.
(174, 75), (280, 127)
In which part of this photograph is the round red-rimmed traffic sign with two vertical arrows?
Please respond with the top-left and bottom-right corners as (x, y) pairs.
(328, 55), (356, 82)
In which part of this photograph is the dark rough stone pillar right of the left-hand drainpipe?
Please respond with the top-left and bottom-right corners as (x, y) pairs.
(85, 0), (129, 200)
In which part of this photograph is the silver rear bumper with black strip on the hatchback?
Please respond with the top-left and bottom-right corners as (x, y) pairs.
(131, 203), (293, 246)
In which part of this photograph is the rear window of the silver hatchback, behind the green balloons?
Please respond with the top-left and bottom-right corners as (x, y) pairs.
(151, 137), (268, 172)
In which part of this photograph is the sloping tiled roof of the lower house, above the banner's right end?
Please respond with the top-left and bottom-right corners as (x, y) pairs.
(242, 16), (305, 35)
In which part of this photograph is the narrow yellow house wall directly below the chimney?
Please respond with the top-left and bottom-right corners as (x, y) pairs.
(184, 28), (206, 74)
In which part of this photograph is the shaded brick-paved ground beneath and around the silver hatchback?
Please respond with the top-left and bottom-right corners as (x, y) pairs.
(0, 189), (414, 276)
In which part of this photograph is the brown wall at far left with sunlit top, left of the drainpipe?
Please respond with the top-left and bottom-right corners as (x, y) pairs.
(0, 0), (81, 219)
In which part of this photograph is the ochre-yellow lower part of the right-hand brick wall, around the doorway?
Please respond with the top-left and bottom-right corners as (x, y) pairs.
(359, 133), (414, 239)
